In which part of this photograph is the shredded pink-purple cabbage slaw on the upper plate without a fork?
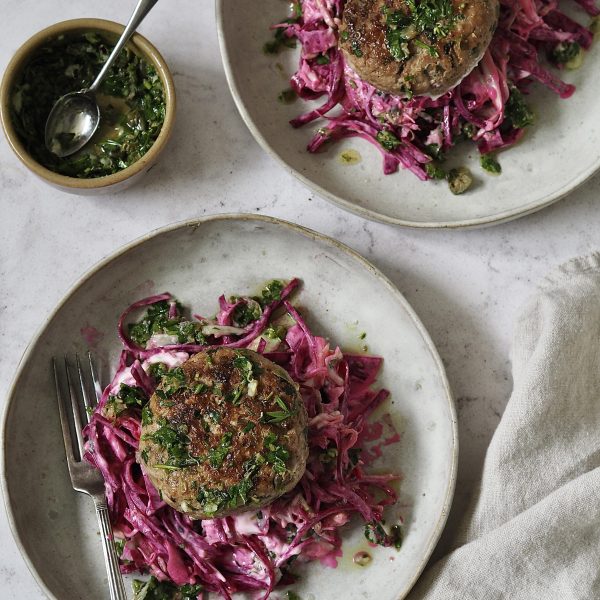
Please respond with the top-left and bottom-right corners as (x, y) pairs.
(274, 0), (600, 180)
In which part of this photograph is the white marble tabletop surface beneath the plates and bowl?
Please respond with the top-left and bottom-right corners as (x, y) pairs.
(0, 0), (600, 600)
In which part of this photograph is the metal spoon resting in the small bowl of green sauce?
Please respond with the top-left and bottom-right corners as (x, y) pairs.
(45, 0), (158, 158)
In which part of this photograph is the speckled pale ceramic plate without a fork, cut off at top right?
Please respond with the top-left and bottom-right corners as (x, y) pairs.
(217, 0), (600, 228)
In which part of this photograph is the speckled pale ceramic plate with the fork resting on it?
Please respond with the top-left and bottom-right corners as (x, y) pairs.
(2, 215), (457, 600)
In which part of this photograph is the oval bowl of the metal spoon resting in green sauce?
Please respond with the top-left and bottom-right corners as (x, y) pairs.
(45, 91), (100, 158)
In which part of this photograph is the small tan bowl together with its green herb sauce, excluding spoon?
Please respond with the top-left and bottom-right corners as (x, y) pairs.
(0, 19), (175, 194)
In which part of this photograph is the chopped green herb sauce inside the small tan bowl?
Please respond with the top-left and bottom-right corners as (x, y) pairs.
(11, 32), (165, 179)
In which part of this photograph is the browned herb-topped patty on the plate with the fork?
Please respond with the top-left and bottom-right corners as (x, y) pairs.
(138, 348), (308, 519)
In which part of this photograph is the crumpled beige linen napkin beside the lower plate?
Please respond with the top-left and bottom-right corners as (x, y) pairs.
(409, 255), (600, 600)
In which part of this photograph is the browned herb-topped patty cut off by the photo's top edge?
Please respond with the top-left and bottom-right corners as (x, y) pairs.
(340, 0), (499, 96)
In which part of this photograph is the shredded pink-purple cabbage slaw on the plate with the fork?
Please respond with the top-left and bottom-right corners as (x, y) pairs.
(84, 279), (400, 599)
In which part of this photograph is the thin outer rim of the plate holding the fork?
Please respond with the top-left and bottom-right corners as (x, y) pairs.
(0, 213), (459, 600)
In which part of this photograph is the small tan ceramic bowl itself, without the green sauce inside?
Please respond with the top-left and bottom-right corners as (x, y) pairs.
(0, 19), (175, 195)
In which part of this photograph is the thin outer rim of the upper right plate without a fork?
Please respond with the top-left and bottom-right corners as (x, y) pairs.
(215, 0), (600, 230)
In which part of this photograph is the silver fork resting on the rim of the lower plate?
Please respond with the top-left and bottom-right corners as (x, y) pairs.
(52, 353), (127, 600)
